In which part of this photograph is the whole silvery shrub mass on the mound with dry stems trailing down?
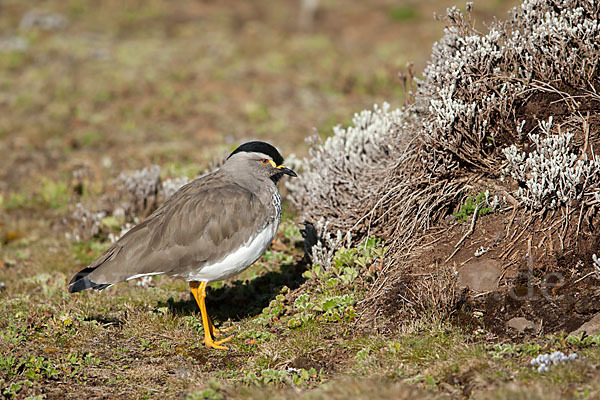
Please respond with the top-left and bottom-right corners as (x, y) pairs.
(288, 0), (600, 324)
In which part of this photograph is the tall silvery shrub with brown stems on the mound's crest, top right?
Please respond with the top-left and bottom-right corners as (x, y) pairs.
(415, 0), (600, 176)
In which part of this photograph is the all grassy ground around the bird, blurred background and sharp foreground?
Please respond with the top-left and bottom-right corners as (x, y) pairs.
(0, 0), (600, 399)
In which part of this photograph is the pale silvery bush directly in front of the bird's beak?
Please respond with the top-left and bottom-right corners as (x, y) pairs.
(286, 104), (415, 232)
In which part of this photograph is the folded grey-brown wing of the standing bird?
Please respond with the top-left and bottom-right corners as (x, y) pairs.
(71, 174), (270, 285)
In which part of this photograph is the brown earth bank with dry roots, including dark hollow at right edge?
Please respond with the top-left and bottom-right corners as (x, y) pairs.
(357, 69), (600, 340)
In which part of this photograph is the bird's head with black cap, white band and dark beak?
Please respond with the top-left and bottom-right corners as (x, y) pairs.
(223, 141), (298, 183)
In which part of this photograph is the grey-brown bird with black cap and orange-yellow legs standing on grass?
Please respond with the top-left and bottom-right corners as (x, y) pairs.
(68, 141), (297, 350)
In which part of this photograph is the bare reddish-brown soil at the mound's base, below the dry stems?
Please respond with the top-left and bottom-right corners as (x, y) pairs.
(368, 209), (600, 340)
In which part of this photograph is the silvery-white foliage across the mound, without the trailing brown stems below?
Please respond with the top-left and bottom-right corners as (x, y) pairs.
(286, 0), (600, 241)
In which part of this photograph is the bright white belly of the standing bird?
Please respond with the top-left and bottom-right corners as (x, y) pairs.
(186, 220), (279, 282)
